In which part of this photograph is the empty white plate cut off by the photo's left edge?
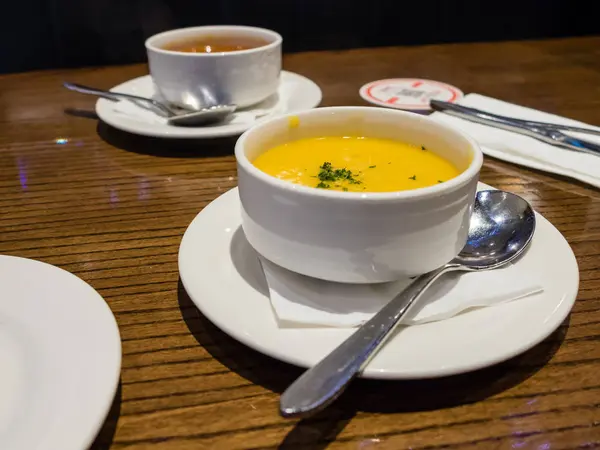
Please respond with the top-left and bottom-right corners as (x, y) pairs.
(0, 256), (121, 450)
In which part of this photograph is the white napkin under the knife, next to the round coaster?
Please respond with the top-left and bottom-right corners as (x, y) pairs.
(431, 94), (600, 187)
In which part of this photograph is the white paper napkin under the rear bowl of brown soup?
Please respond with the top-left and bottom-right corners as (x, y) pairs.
(111, 92), (288, 126)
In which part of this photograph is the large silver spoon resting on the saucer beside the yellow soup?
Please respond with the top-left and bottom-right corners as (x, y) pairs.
(279, 191), (535, 417)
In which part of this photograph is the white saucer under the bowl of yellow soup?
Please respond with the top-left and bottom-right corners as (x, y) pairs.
(179, 183), (579, 379)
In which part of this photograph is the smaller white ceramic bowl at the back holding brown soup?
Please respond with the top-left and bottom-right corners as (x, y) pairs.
(146, 25), (282, 109)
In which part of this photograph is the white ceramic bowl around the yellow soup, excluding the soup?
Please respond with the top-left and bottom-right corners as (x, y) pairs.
(235, 107), (483, 283)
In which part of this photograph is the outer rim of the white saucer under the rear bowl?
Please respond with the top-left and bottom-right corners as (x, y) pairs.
(96, 70), (323, 139)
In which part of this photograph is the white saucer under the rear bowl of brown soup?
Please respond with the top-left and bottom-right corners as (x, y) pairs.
(96, 70), (322, 139)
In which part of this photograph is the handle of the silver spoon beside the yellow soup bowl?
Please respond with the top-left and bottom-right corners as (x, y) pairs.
(279, 264), (460, 417)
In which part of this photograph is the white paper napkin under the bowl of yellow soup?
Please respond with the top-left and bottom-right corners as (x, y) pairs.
(260, 258), (543, 327)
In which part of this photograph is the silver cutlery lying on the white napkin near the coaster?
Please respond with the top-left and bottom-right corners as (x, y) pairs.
(431, 100), (600, 156)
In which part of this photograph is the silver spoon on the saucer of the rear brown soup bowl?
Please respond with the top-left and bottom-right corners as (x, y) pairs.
(63, 82), (237, 126)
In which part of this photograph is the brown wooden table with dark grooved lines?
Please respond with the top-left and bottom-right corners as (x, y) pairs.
(0, 38), (600, 450)
